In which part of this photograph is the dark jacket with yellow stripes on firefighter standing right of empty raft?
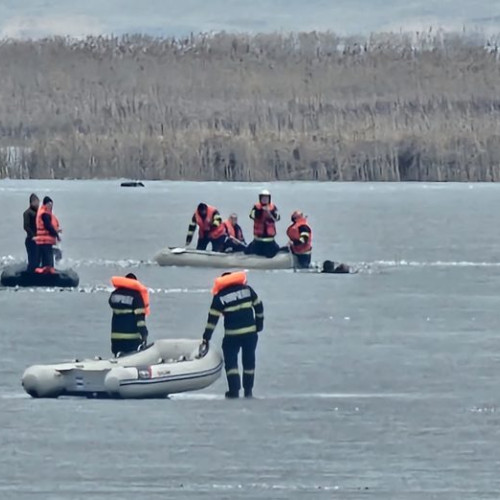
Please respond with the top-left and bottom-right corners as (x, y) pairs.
(203, 285), (264, 340)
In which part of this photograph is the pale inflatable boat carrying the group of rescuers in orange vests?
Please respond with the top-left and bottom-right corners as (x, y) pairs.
(155, 247), (294, 269)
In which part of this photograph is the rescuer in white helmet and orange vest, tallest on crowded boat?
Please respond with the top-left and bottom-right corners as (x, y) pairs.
(245, 189), (280, 258)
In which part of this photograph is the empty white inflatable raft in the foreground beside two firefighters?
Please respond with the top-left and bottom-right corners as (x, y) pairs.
(22, 339), (223, 398)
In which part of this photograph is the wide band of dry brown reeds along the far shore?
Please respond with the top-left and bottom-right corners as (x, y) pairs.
(0, 33), (500, 181)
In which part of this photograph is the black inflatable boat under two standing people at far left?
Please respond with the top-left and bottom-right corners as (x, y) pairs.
(0, 264), (80, 288)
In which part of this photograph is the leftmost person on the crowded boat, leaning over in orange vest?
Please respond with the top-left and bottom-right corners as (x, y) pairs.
(186, 203), (227, 252)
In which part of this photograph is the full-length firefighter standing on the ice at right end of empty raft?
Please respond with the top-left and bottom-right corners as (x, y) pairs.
(203, 271), (264, 398)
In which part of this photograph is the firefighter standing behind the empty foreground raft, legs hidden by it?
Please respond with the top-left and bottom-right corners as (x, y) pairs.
(108, 273), (150, 356)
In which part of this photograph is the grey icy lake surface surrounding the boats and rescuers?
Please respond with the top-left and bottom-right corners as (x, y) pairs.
(0, 180), (500, 500)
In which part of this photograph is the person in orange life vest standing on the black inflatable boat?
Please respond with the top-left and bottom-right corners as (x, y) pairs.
(35, 196), (62, 273)
